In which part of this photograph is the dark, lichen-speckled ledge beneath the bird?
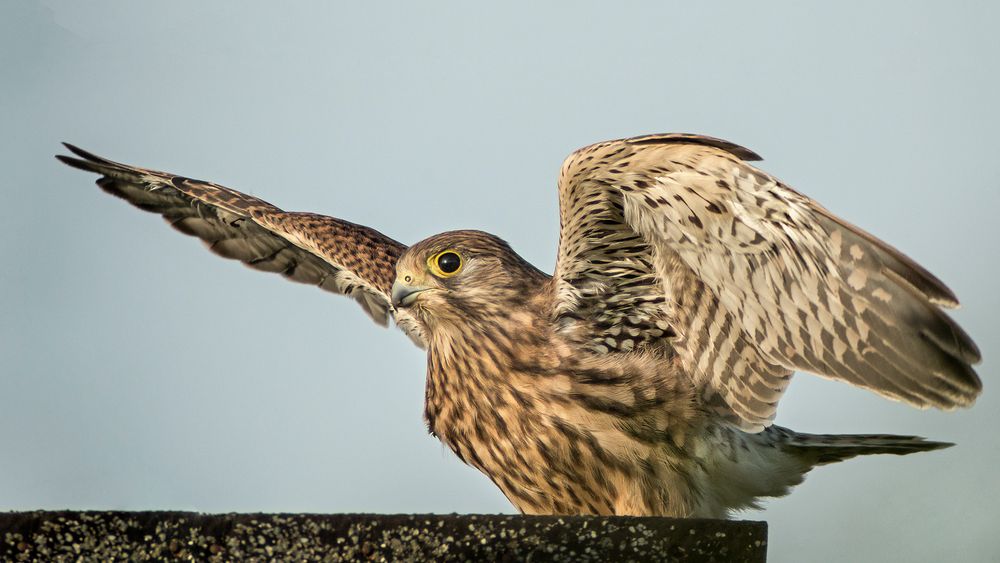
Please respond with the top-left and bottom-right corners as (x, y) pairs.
(0, 512), (767, 561)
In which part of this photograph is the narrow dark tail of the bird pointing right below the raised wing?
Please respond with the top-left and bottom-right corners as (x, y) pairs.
(772, 427), (955, 466)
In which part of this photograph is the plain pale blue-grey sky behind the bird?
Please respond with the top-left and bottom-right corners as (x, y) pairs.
(0, 0), (1000, 561)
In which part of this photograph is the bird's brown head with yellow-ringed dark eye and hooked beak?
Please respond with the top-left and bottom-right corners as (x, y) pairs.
(392, 231), (547, 326)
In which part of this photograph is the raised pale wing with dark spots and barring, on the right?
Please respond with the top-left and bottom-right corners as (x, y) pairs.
(556, 135), (982, 429)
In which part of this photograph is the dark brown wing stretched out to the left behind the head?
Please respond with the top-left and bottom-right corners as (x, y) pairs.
(56, 144), (423, 346)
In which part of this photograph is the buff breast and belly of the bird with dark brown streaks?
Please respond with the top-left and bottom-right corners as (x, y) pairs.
(425, 328), (704, 514)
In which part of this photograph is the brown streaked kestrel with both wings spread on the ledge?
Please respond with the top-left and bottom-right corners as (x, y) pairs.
(57, 133), (982, 518)
